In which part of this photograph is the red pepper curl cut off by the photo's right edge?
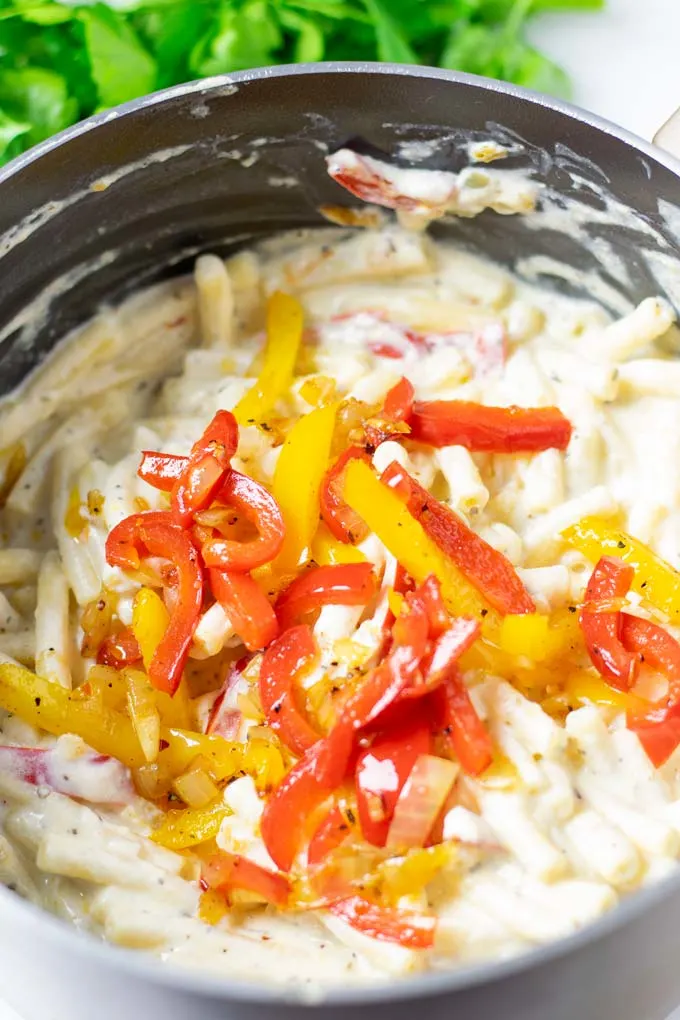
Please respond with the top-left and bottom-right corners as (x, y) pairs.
(621, 613), (680, 768)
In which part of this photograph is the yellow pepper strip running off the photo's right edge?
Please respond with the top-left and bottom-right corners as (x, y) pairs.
(562, 517), (680, 623)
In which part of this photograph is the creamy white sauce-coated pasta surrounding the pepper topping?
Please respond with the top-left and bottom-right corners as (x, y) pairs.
(0, 147), (680, 986)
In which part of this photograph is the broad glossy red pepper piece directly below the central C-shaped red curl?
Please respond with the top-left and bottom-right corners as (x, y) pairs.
(260, 745), (328, 871)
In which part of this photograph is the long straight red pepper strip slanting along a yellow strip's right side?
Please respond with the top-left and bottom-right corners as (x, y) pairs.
(380, 461), (535, 613)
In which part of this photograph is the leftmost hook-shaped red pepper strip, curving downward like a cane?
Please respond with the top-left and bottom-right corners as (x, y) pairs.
(106, 512), (203, 695)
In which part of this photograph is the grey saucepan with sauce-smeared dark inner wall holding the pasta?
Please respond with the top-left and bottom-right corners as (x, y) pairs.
(0, 63), (680, 1020)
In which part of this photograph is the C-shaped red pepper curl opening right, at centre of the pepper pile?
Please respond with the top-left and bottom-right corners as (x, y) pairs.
(260, 623), (321, 755)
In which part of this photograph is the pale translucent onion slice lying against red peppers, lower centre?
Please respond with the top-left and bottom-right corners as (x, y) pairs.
(386, 755), (460, 850)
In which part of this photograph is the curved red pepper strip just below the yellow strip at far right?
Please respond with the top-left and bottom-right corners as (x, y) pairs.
(579, 556), (640, 691)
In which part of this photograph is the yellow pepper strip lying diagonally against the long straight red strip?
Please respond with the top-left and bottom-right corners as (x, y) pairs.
(344, 460), (499, 629)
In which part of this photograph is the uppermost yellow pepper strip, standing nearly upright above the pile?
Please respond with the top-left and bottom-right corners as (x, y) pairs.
(233, 291), (304, 425)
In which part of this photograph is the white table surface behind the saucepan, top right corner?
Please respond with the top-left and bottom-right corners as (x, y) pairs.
(0, 0), (680, 1020)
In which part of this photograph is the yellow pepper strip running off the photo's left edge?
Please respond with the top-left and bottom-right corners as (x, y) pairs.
(0, 663), (146, 767)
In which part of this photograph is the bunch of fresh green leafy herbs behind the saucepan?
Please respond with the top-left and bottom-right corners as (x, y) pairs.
(0, 0), (605, 164)
